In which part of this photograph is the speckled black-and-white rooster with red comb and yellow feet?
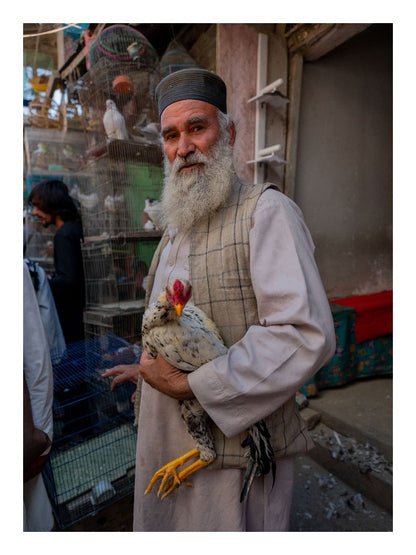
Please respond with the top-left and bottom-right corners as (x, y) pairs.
(142, 279), (276, 501)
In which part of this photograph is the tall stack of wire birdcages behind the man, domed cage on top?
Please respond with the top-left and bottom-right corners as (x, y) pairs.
(72, 25), (163, 343)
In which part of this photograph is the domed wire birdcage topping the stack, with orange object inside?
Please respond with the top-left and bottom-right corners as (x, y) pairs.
(78, 25), (160, 151)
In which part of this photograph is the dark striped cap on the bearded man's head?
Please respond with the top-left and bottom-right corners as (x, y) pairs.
(156, 68), (227, 116)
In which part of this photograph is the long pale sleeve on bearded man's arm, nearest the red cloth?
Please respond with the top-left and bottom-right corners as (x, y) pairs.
(188, 190), (335, 437)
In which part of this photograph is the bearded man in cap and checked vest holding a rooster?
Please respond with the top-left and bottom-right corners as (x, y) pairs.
(104, 68), (335, 531)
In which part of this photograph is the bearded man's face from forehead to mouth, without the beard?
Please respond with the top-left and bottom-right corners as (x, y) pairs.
(161, 100), (228, 167)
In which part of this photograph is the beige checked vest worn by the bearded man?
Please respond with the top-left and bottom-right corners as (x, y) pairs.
(146, 179), (313, 468)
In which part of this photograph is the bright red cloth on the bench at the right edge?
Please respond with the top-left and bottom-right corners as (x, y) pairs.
(331, 290), (393, 343)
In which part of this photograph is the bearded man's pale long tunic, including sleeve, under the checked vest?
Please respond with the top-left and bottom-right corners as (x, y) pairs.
(133, 189), (335, 531)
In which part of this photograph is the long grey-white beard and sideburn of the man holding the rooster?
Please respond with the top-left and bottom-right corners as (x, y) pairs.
(161, 133), (234, 232)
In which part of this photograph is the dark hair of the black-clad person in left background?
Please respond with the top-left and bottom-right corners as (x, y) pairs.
(28, 179), (80, 222)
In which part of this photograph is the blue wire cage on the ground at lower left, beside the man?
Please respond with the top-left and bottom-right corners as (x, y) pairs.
(43, 334), (141, 529)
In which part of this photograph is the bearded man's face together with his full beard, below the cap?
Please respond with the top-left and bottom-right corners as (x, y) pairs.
(161, 100), (235, 231)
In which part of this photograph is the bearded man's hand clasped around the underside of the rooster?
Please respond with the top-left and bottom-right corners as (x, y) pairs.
(140, 351), (195, 400)
